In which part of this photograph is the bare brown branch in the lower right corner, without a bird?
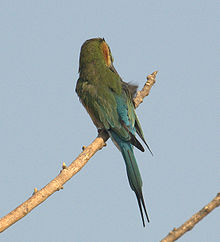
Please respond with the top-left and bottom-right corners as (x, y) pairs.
(161, 193), (220, 242)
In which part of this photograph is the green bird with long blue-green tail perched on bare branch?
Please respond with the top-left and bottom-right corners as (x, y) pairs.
(76, 38), (151, 226)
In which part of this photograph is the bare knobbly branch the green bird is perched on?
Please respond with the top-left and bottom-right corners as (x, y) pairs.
(0, 72), (157, 232)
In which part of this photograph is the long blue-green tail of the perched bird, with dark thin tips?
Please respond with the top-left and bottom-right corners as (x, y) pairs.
(111, 132), (150, 227)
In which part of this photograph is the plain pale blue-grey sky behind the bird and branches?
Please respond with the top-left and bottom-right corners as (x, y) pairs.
(0, 0), (220, 242)
